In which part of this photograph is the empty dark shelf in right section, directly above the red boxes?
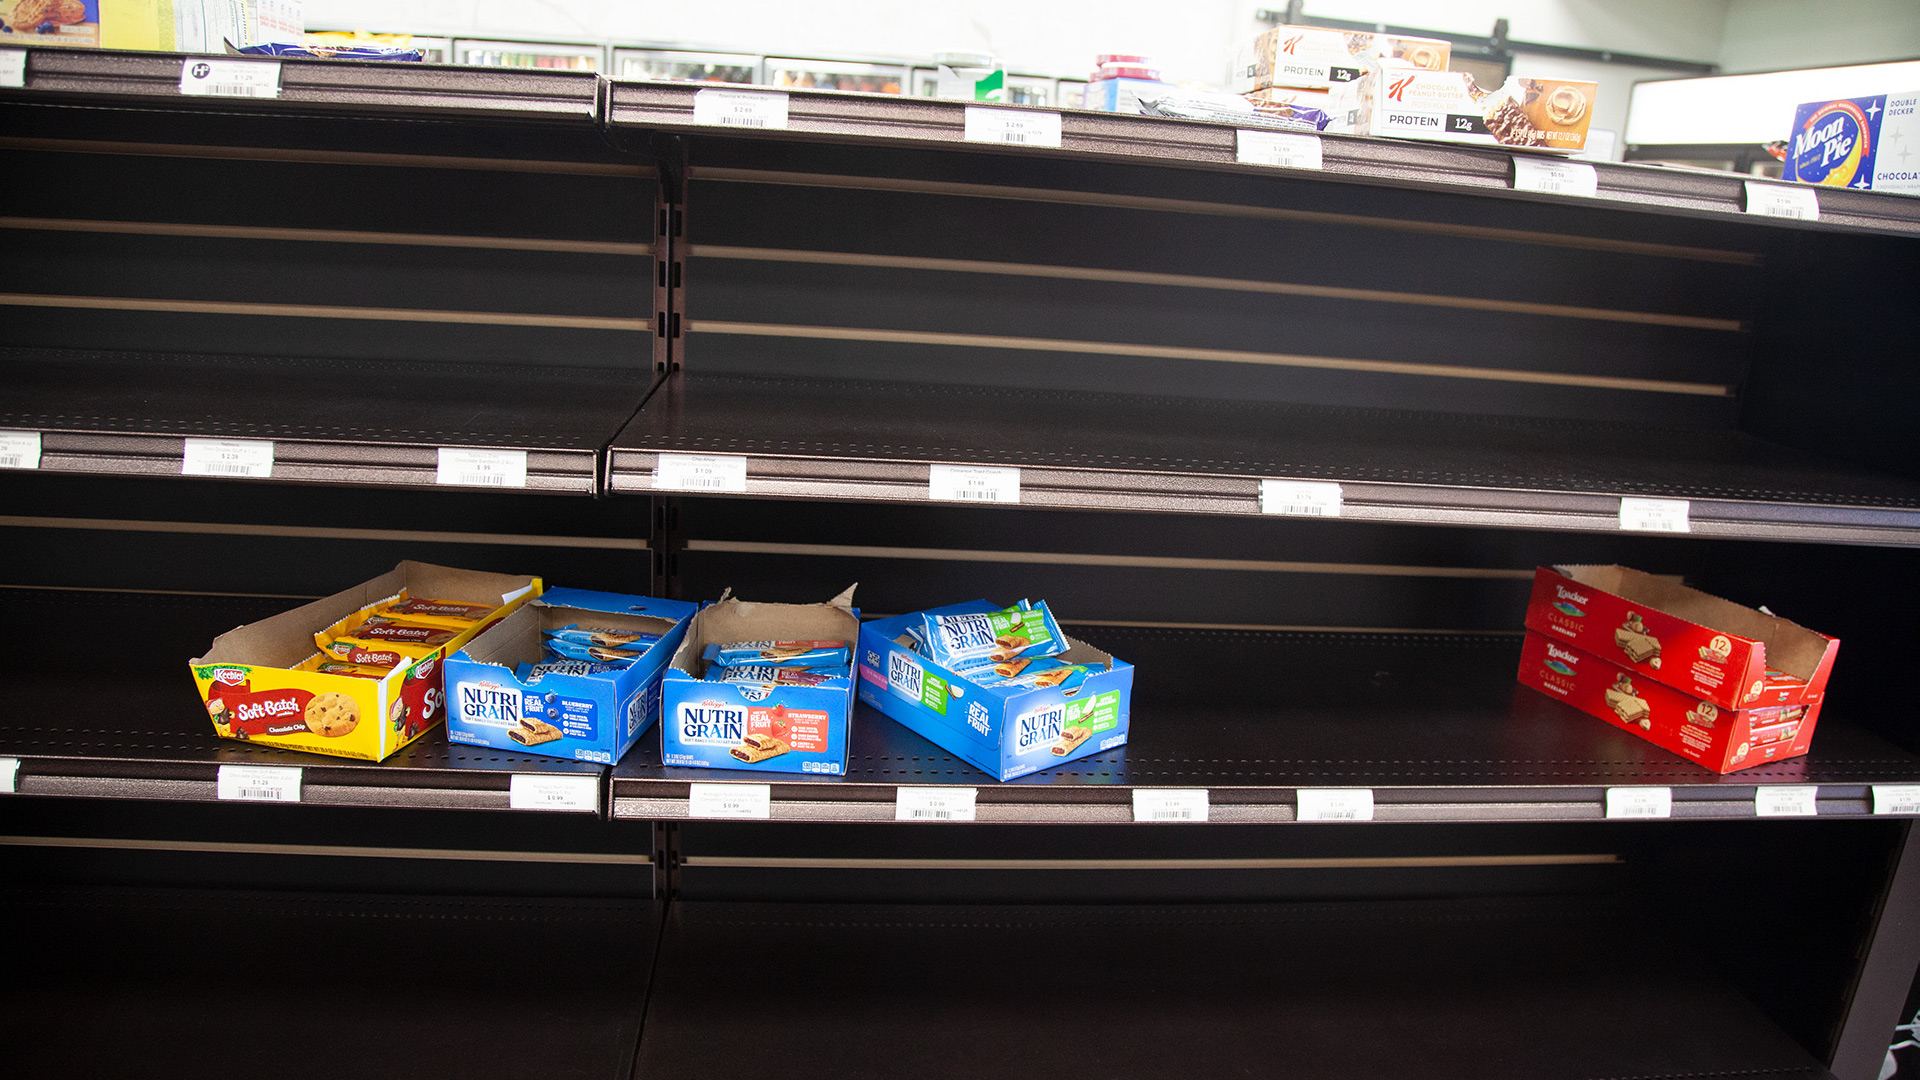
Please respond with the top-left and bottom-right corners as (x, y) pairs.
(609, 375), (1920, 546)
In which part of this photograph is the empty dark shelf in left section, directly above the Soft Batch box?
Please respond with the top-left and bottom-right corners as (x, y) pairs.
(0, 348), (653, 494)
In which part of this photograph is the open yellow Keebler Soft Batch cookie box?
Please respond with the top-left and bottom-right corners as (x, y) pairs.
(188, 561), (541, 761)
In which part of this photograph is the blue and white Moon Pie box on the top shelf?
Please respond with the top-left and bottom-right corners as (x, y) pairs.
(1780, 90), (1920, 194)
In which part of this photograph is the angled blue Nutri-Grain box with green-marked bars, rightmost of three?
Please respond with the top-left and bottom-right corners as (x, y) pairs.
(856, 600), (1133, 780)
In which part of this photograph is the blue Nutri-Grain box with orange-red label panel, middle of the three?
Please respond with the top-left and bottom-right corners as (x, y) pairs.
(660, 586), (860, 776)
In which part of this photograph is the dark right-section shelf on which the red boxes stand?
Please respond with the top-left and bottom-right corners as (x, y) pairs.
(612, 626), (1920, 822)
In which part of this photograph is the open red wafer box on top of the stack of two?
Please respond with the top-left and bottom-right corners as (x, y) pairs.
(1526, 567), (1839, 709)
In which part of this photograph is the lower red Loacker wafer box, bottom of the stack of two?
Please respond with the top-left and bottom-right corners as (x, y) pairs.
(1521, 630), (1820, 773)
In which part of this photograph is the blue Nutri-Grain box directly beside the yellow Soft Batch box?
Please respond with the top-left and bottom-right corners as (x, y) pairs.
(445, 588), (699, 765)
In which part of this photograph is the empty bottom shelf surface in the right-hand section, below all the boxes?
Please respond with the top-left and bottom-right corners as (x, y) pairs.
(634, 897), (1828, 1080)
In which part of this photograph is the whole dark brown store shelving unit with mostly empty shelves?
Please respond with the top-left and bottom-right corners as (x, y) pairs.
(0, 50), (1920, 1080)
